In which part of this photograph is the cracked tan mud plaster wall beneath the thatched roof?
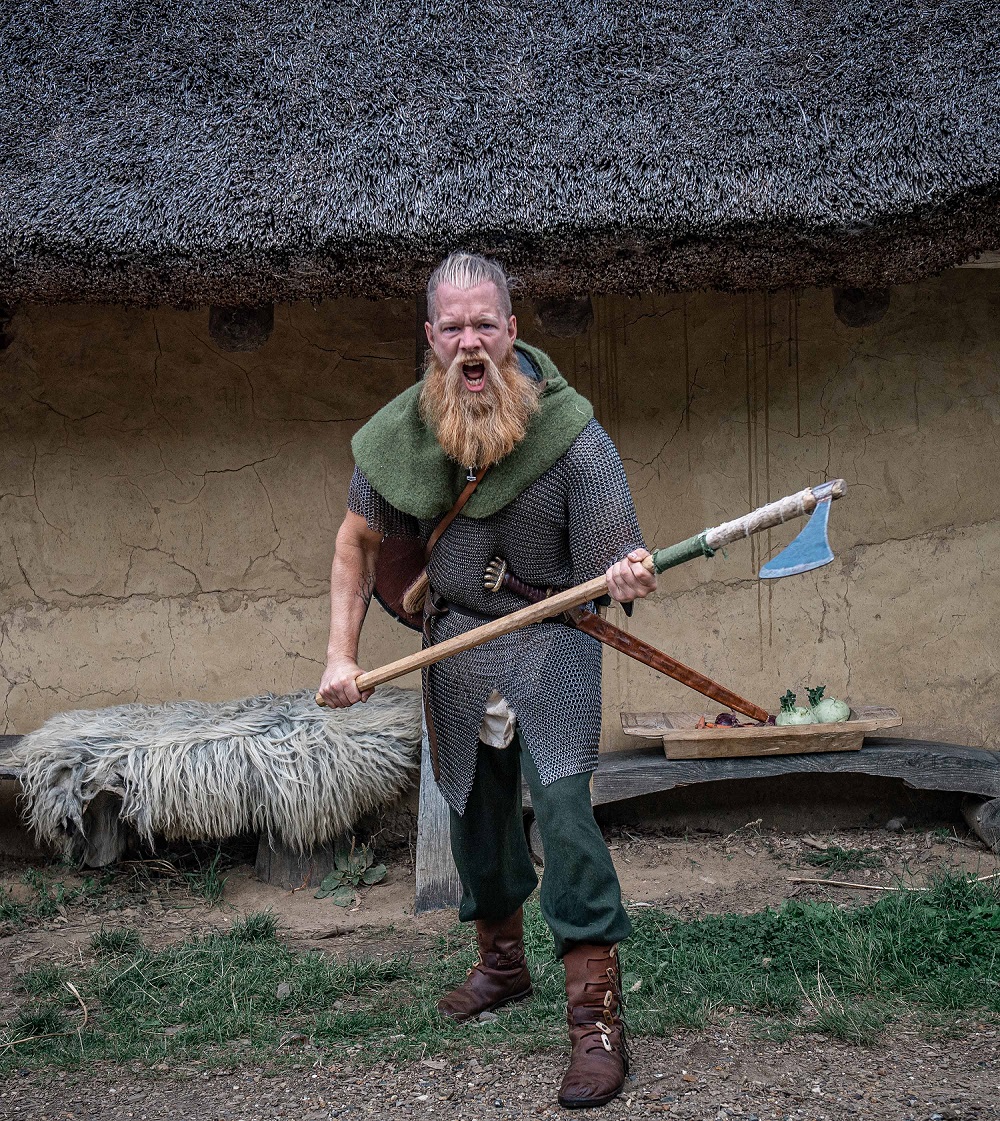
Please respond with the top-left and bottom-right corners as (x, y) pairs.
(0, 271), (1000, 747)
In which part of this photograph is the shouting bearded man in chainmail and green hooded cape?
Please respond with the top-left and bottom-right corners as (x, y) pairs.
(320, 253), (656, 1109)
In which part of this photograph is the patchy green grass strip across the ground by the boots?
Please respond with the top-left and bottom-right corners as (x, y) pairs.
(0, 877), (1000, 1073)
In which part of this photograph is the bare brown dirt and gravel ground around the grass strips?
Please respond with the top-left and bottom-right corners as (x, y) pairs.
(0, 824), (1000, 1121)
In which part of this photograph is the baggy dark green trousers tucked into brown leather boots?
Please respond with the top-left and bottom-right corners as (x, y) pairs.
(452, 734), (632, 957)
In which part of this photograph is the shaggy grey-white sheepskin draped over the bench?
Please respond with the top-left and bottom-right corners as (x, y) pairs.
(17, 687), (420, 853)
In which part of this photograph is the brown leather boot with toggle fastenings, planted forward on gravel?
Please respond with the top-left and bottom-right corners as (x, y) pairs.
(559, 943), (629, 1110)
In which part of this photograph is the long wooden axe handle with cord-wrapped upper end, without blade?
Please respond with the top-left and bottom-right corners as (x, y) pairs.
(316, 479), (846, 705)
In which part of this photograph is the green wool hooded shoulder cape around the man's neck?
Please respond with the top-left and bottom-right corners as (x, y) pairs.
(351, 340), (594, 518)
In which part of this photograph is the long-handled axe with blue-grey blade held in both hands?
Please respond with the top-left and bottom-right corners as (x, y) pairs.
(316, 479), (848, 705)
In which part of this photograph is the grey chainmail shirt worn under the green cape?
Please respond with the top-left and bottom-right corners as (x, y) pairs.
(348, 420), (643, 814)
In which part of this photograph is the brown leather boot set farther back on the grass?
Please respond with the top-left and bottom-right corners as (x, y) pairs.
(437, 908), (531, 1023)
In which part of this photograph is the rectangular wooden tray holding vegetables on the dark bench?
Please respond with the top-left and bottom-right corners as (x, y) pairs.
(621, 705), (902, 759)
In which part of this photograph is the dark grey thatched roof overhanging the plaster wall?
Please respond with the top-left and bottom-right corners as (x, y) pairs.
(0, 0), (1000, 304)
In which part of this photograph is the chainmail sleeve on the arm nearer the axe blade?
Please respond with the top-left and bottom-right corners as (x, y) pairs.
(566, 420), (646, 584)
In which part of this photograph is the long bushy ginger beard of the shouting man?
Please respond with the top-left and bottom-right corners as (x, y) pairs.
(420, 338), (539, 470)
